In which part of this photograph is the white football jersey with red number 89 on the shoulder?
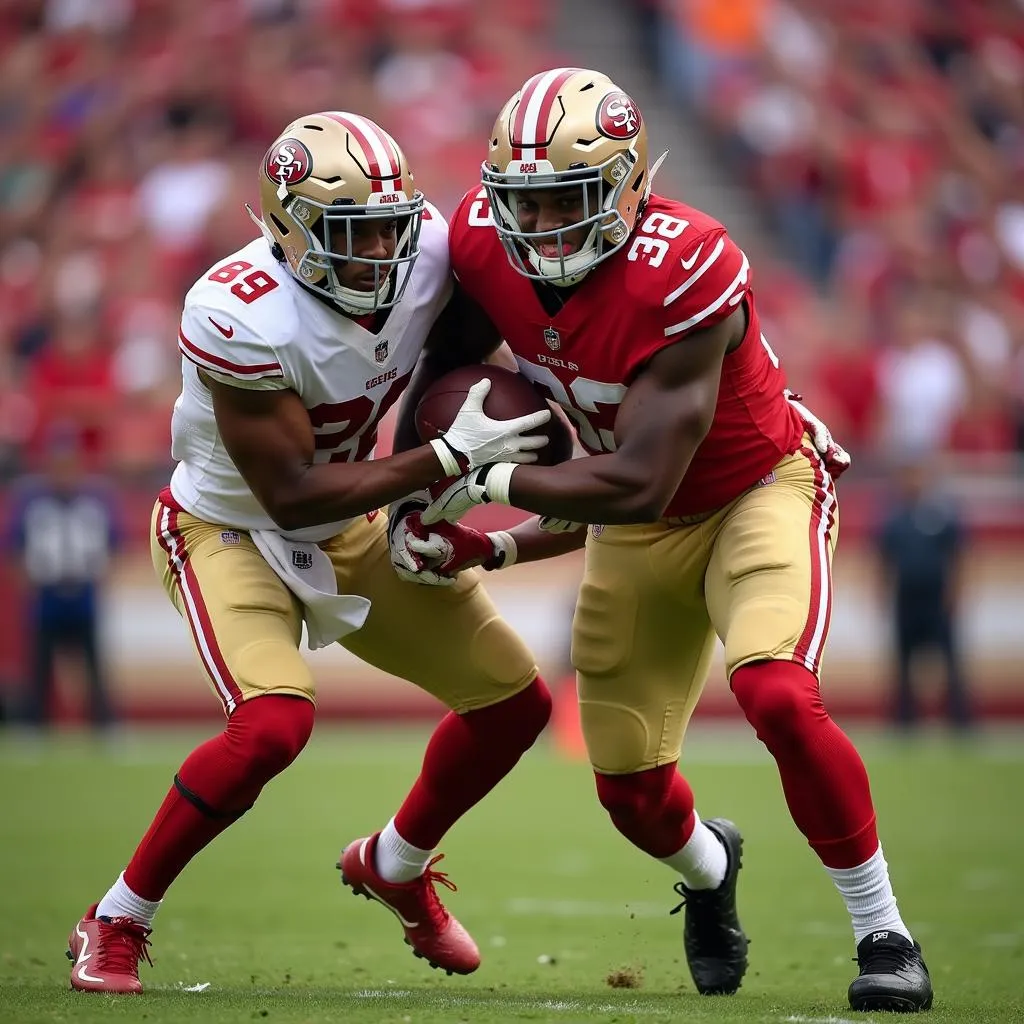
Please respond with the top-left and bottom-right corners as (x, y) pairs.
(171, 194), (452, 541)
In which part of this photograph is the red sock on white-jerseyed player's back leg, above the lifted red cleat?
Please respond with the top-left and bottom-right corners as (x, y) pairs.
(394, 676), (551, 850)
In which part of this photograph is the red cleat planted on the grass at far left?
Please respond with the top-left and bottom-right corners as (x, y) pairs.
(68, 903), (153, 995)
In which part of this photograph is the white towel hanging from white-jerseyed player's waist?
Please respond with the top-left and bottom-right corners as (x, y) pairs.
(250, 529), (370, 650)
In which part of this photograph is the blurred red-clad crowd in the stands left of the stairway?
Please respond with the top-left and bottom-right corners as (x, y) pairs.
(0, 0), (559, 497)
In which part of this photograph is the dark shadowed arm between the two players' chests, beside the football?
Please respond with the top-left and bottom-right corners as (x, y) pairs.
(394, 283), (502, 452)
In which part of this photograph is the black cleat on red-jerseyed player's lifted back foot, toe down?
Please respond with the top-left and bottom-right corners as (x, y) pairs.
(672, 818), (750, 995)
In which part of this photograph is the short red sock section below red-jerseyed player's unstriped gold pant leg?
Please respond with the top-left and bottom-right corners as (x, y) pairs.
(594, 762), (696, 859)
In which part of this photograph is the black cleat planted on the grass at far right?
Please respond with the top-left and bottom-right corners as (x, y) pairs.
(850, 932), (932, 1014)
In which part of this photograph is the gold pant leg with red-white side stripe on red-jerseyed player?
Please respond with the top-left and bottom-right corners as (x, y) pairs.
(707, 438), (839, 675)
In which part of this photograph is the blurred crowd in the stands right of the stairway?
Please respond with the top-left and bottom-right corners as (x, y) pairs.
(632, 0), (1024, 473)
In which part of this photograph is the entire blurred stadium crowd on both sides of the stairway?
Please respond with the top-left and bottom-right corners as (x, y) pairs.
(0, 0), (1024, 499)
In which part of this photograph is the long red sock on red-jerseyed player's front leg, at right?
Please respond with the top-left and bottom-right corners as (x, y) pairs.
(730, 662), (879, 867)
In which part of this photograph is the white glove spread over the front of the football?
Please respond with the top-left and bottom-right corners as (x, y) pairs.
(430, 377), (551, 476)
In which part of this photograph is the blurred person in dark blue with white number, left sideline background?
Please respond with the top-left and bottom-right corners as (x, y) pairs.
(5, 425), (121, 729)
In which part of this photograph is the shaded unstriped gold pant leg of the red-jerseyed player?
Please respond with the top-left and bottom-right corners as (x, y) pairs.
(572, 523), (715, 774)
